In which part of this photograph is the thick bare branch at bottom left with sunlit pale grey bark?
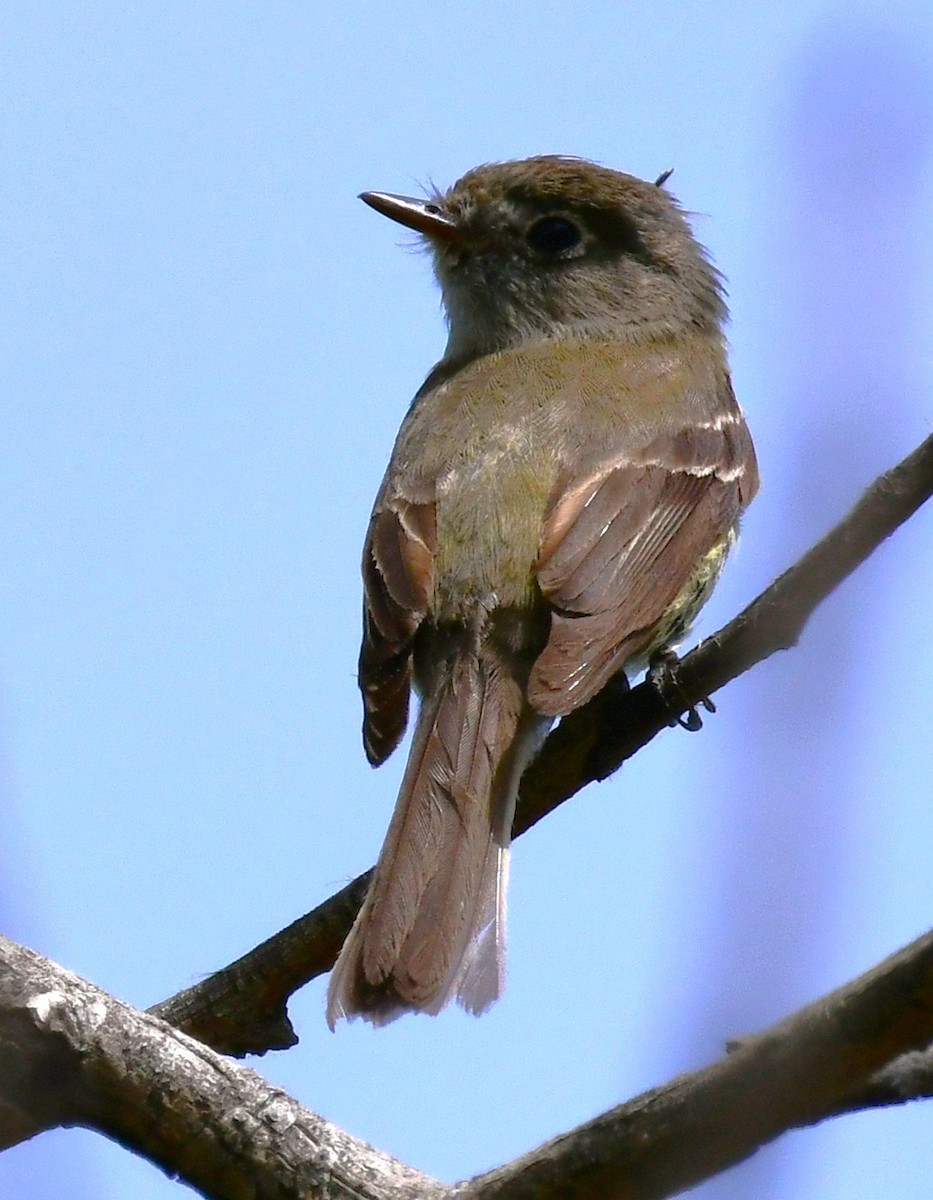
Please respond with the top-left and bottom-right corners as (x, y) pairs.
(0, 937), (449, 1200)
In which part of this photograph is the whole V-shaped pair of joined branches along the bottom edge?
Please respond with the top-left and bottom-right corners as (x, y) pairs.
(0, 932), (933, 1200)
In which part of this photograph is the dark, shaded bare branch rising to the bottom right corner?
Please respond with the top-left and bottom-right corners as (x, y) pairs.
(457, 934), (933, 1200)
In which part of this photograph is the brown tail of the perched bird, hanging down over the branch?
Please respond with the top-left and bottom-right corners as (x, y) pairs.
(327, 649), (541, 1028)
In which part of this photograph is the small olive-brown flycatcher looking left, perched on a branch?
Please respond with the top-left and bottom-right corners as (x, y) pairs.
(327, 156), (758, 1027)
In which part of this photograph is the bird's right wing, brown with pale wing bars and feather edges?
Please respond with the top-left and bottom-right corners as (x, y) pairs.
(529, 376), (758, 715)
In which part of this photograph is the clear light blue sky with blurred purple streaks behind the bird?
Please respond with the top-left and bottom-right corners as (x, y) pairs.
(0, 0), (933, 1200)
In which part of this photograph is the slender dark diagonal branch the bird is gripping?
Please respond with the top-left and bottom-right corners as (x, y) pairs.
(150, 436), (933, 1055)
